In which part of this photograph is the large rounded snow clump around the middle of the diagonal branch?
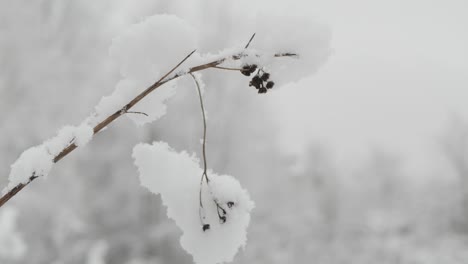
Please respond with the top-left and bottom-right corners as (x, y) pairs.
(88, 14), (199, 125)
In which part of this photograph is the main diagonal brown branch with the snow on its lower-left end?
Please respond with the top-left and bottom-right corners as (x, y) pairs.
(0, 50), (298, 207)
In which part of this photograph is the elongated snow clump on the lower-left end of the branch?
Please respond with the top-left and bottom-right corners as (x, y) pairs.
(3, 122), (93, 193)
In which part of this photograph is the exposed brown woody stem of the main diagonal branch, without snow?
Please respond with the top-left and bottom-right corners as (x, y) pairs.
(0, 49), (297, 207)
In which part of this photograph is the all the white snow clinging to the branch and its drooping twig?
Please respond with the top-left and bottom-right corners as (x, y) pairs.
(4, 9), (330, 264)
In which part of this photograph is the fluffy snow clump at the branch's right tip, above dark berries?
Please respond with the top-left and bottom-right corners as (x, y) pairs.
(251, 13), (331, 85)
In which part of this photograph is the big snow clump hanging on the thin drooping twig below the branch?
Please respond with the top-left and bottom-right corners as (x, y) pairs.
(133, 142), (254, 264)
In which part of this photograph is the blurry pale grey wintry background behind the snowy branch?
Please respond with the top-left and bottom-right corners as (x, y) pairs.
(0, 0), (468, 264)
